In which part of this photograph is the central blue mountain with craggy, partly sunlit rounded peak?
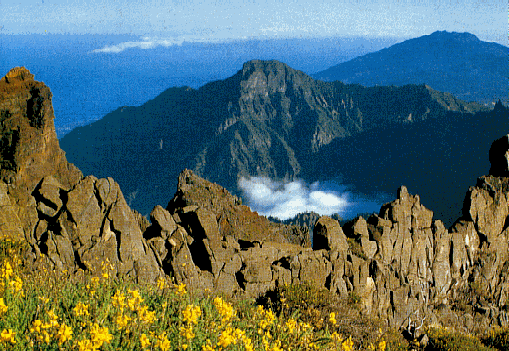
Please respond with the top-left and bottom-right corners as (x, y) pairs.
(60, 60), (483, 221)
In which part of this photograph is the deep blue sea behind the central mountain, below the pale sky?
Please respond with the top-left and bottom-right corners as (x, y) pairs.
(0, 34), (406, 137)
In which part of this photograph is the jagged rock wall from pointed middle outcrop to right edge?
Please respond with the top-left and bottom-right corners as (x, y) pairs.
(144, 135), (509, 329)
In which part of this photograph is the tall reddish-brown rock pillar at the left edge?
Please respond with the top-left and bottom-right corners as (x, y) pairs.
(0, 67), (82, 233)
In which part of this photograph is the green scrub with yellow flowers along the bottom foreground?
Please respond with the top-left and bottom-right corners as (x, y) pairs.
(0, 239), (509, 351)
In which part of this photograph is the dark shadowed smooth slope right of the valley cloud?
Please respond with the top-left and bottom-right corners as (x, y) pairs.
(304, 103), (509, 225)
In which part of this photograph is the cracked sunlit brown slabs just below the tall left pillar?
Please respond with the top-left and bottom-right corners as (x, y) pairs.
(27, 176), (163, 282)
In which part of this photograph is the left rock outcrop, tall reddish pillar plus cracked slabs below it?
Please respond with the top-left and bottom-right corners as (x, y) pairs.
(0, 67), (162, 281)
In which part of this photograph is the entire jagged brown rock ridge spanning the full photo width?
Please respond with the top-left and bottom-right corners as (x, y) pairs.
(0, 69), (509, 331)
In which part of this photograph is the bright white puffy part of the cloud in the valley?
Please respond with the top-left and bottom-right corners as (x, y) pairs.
(239, 177), (350, 219)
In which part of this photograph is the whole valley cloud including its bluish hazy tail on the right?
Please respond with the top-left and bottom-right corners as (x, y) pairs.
(238, 177), (391, 220)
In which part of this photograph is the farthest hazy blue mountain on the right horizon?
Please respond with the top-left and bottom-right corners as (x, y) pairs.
(313, 31), (509, 103)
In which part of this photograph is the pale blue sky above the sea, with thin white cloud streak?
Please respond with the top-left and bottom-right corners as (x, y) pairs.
(0, 0), (507, 53)
